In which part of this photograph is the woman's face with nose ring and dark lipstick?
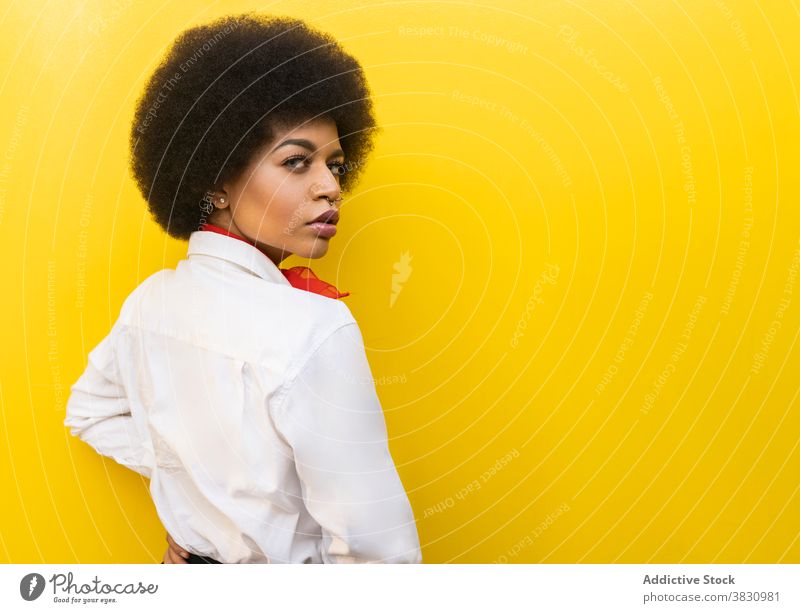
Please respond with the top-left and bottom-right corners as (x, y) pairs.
(208, 118), (345, 265)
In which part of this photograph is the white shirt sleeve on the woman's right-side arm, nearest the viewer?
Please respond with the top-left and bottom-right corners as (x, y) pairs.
(272, 322), (422, 564)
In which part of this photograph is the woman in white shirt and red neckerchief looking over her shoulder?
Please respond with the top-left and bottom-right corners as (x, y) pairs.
(65, 14), (422, 563)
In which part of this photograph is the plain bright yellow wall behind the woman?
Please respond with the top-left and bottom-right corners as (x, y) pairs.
(0, 0), (800, 563)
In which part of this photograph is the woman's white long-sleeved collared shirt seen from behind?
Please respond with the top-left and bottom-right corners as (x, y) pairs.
(64, 231), (422, 563)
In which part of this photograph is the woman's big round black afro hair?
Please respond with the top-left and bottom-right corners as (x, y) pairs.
(129, 13), (377, 239)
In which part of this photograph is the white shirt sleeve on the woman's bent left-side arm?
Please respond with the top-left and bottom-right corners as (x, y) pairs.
(64, 326), (155, 479)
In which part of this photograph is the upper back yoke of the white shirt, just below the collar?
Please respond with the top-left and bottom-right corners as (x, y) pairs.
(111, 262), (355, 374)
